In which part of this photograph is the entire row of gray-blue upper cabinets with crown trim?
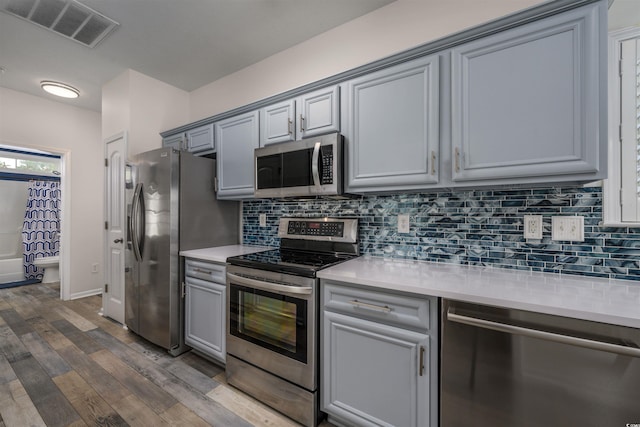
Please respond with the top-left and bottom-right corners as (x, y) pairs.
(163, 0), (607, 194)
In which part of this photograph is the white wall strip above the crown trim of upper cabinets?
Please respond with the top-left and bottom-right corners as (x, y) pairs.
(189, 0), (543, 121)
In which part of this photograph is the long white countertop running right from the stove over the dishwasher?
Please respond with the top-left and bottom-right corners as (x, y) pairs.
(318, 256), (640, 328)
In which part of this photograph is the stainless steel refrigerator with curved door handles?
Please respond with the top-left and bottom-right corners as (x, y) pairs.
(125, 148), (239, 356)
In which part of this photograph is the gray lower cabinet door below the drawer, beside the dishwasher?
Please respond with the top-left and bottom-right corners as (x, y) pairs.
(321, 311), (430, 427)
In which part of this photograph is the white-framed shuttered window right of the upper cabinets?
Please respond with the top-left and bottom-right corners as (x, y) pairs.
(603, 28), (640, 227)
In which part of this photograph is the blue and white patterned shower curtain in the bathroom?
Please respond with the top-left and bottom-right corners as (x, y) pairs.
(22, 181), (60, 280)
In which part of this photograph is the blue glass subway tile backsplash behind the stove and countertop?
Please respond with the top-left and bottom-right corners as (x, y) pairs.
(243, 187), (640, 280)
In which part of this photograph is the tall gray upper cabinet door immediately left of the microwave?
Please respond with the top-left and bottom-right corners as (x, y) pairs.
(215, 111), (260, 200)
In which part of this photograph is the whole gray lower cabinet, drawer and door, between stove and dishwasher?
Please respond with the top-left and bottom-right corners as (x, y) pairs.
(321, 281), (438, 427)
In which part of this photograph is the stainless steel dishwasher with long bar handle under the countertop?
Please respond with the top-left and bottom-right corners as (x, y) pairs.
(440, 300), (640, 427)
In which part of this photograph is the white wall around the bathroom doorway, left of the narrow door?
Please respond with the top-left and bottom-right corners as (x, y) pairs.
(0, 87), (104, 298)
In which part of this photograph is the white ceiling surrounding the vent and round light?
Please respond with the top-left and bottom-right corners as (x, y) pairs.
(0, 0), (640, 111)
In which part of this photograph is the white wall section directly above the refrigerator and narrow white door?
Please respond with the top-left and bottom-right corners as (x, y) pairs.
(102, 70), (189, 155)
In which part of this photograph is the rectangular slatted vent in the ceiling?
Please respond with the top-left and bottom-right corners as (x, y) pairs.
(0, 0), (120, 47)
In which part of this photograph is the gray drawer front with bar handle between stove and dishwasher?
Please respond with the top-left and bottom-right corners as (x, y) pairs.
(322, 281), (437, 330)
